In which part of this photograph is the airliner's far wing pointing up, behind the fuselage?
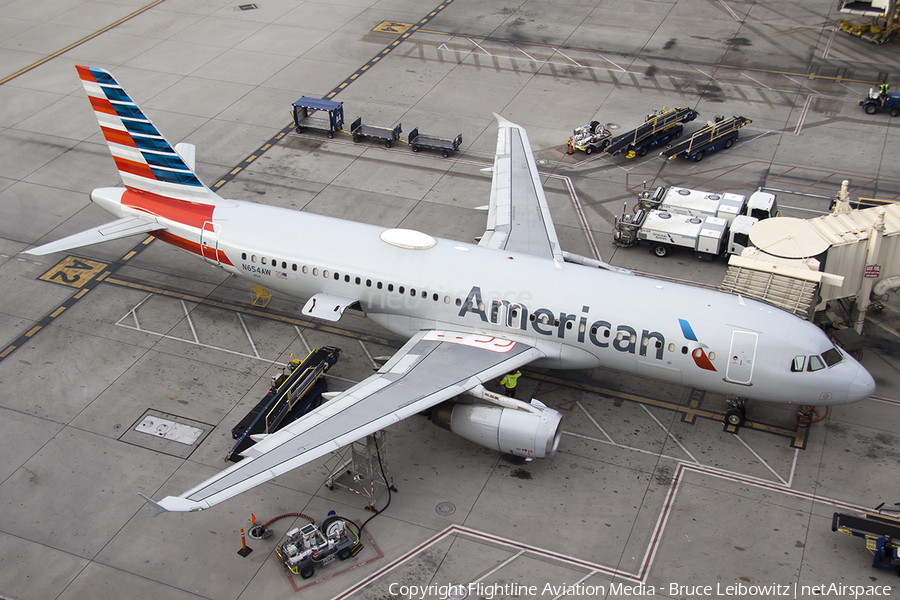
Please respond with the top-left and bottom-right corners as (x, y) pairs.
(478, 114), (563, 263)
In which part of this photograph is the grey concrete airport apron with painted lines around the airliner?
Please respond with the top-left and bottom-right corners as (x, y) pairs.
(0, 0), (900, 600)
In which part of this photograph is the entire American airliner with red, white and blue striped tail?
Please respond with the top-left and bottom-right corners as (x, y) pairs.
(28, 67), (875, 516)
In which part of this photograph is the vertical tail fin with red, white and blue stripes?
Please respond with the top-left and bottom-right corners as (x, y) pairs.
(76, 66), (220, 204)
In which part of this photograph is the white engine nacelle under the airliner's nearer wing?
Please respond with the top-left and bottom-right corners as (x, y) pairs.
(431, 402), (562, 458)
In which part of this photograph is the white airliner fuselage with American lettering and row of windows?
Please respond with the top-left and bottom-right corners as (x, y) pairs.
(94, 189), (873, 405)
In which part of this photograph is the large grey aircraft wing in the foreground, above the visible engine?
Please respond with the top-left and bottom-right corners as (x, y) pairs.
(141, 331), (544, 517)
